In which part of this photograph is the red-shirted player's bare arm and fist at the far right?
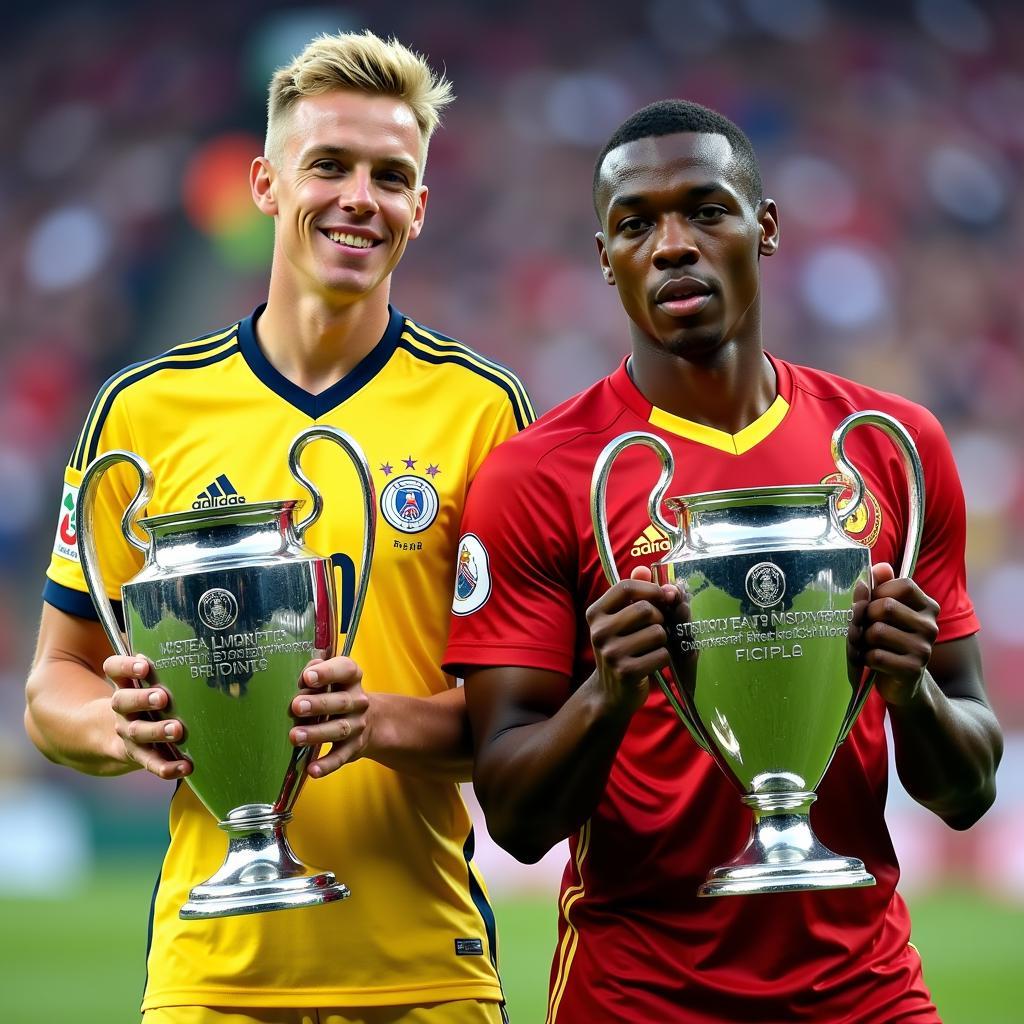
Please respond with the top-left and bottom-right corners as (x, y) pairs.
(847, 563), (1002, 828)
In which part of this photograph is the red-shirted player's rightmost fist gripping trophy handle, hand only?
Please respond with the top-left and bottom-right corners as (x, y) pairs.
(849, 562), (939, 707)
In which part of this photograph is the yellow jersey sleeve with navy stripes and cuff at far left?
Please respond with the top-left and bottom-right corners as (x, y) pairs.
(43, 391), (142, 620)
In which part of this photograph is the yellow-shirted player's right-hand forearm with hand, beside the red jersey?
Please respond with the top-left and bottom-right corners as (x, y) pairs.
(290, 657), (473, 782)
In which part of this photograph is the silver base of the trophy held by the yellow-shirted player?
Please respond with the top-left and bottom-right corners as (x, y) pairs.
(178, 804), (351, 921)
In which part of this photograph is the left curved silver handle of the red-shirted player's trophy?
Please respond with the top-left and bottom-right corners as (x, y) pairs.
(590, 430), (709, 751)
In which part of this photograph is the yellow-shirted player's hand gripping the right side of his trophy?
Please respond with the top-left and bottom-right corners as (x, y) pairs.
(289, 657), (371, 778)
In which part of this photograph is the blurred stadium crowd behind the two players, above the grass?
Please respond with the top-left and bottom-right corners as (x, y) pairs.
(0, 0), (1024, 899)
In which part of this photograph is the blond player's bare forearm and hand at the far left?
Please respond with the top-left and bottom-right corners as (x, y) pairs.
(25, 603), (191, 778)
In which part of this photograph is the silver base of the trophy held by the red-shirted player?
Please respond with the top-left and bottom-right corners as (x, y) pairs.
(697, 793), (874, 896)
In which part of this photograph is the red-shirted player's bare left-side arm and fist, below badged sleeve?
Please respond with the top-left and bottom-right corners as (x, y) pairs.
(465, 569), (679, 863)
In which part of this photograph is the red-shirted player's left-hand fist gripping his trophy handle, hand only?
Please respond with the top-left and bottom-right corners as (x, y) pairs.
(587, 566), (681, 713)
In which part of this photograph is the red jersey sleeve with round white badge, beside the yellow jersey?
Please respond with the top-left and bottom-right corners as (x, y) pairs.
(444, 441), (578, 675)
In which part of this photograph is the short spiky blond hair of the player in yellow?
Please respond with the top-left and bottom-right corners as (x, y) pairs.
(264, 29), (455, 171)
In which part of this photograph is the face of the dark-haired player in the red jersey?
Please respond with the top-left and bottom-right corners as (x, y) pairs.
(597, 132), (778, 358)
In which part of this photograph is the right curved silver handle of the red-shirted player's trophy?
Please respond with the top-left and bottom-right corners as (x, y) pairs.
(831, 410), (925, 742)
